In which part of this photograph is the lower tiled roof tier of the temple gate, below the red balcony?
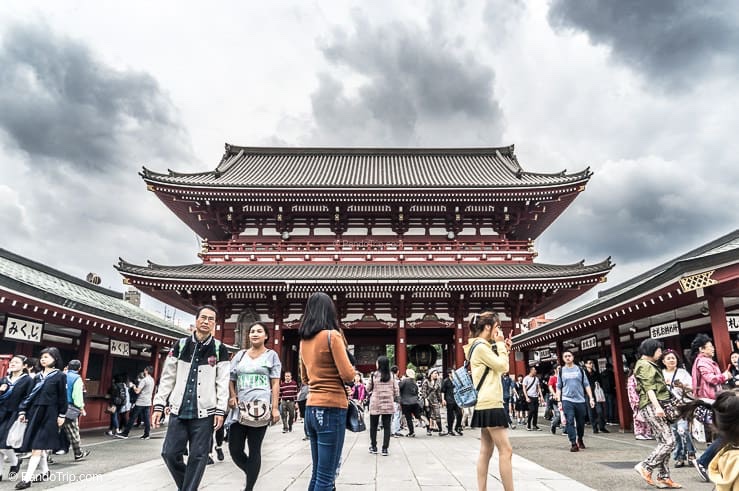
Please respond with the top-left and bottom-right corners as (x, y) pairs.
(117, 259), (612, 283)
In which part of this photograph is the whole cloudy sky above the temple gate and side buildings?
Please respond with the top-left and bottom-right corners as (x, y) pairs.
(0, 0), (739, 320)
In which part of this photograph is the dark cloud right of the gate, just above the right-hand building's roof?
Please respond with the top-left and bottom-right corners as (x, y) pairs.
(542, 159), (739, 269)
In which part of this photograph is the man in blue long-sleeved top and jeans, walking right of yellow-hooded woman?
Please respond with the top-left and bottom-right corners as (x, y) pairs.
(554, 350), (595, 452)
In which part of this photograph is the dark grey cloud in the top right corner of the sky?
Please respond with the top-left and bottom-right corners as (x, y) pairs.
(549, 0), (739, 89)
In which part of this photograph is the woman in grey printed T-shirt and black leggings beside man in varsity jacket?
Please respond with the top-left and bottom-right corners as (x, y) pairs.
(228, 322), (282, 491)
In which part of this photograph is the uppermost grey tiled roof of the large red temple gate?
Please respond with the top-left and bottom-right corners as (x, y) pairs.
(142, 144), (591, 189)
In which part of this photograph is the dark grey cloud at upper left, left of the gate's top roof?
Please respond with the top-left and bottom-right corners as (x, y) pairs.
(0, 25), (188, 172)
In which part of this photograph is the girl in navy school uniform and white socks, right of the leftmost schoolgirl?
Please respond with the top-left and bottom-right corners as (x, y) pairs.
(15, 348), (67, 489)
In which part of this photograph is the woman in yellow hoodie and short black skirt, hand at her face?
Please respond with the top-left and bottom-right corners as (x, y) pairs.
(464, 312), (513, 491)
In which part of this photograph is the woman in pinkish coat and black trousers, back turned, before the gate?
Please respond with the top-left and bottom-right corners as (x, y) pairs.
(367, 355), (400, 456)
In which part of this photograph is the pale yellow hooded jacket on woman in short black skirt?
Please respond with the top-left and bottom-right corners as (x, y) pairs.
(464, 338), (508, 409)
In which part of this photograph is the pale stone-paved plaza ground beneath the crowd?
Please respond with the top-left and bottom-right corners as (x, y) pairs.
(11, 423), (712, 491)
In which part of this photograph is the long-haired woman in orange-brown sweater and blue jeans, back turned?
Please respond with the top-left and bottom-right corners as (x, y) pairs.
(298, 292), (355, 491)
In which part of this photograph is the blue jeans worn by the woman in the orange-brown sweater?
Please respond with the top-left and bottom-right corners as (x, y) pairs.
(305, 406), (346, 491)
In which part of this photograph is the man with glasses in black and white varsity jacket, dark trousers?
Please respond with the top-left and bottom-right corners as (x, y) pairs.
(151, 305), (230, 491)
